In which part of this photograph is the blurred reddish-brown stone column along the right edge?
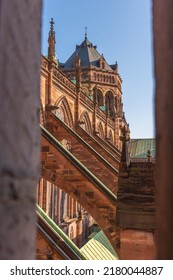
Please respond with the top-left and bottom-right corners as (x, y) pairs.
(153, 0), (173, 259)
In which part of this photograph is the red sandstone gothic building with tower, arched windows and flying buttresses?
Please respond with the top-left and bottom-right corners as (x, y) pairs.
(37, 20), (154, 259)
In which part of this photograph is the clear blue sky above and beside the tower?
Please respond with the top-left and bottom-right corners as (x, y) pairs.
(42, 0), (154, 138)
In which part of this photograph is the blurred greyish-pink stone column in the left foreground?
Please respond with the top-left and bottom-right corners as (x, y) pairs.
(0, 0), (42, 259)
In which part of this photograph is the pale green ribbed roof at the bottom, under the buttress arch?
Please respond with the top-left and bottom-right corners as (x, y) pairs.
(80, 230), (118, 260)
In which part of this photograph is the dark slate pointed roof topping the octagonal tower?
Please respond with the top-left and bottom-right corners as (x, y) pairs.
(63, 38), (112, 71)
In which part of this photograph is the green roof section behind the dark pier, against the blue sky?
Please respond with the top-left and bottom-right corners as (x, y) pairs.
(129, 138), (156, 158)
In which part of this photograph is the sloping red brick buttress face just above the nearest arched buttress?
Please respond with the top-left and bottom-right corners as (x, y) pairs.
(47, 112), (118, 193)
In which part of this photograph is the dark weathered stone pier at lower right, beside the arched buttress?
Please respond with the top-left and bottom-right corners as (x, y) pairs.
(116, 162), (156, 259)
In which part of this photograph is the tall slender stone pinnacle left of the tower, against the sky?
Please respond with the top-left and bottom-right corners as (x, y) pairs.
(48, 18), (56, 61)
